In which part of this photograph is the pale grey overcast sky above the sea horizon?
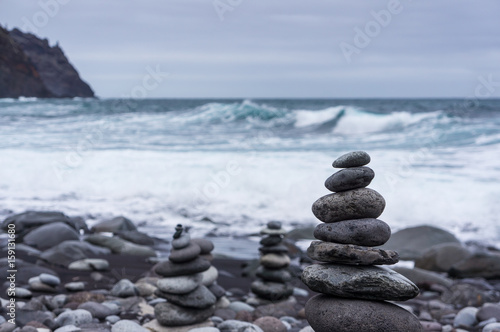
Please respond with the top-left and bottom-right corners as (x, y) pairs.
(0, 0), (500, 98)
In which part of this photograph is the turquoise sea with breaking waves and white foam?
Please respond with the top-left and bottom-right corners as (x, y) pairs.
(0, 99), (500, 242)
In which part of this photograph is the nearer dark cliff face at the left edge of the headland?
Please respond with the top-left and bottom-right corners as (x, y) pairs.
(0, 27), (53, 98)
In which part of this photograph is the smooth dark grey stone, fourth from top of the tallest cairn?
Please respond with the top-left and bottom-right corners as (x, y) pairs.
(314, 218), (391, 247)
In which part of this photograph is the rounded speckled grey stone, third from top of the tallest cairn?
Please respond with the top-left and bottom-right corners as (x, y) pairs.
(312, 188), (385, 223)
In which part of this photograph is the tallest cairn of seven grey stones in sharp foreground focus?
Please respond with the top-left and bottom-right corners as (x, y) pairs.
(301, 151), (422, 332)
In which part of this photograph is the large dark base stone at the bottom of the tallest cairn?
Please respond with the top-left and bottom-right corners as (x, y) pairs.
(305, 295), (423, 332)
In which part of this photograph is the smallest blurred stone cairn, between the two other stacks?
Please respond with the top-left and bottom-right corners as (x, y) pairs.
(251, 221), (293, 301)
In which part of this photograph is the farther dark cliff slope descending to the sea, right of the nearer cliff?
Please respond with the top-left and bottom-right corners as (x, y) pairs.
(9, 29), (94, 98)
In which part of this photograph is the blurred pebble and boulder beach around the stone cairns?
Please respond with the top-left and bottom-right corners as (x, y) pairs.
(0, 212), (500, 332)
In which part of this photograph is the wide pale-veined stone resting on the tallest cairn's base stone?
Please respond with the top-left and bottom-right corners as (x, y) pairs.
(301, 264), (419, 301)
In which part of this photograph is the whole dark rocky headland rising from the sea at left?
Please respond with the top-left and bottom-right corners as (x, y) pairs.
(0, 27), (94, 98)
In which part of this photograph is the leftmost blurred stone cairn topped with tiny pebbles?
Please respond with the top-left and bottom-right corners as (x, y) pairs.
(154, 225), (224, 327)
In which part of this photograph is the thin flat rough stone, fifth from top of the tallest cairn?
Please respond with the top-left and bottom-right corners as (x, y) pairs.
(307, 241), (399, 265)
